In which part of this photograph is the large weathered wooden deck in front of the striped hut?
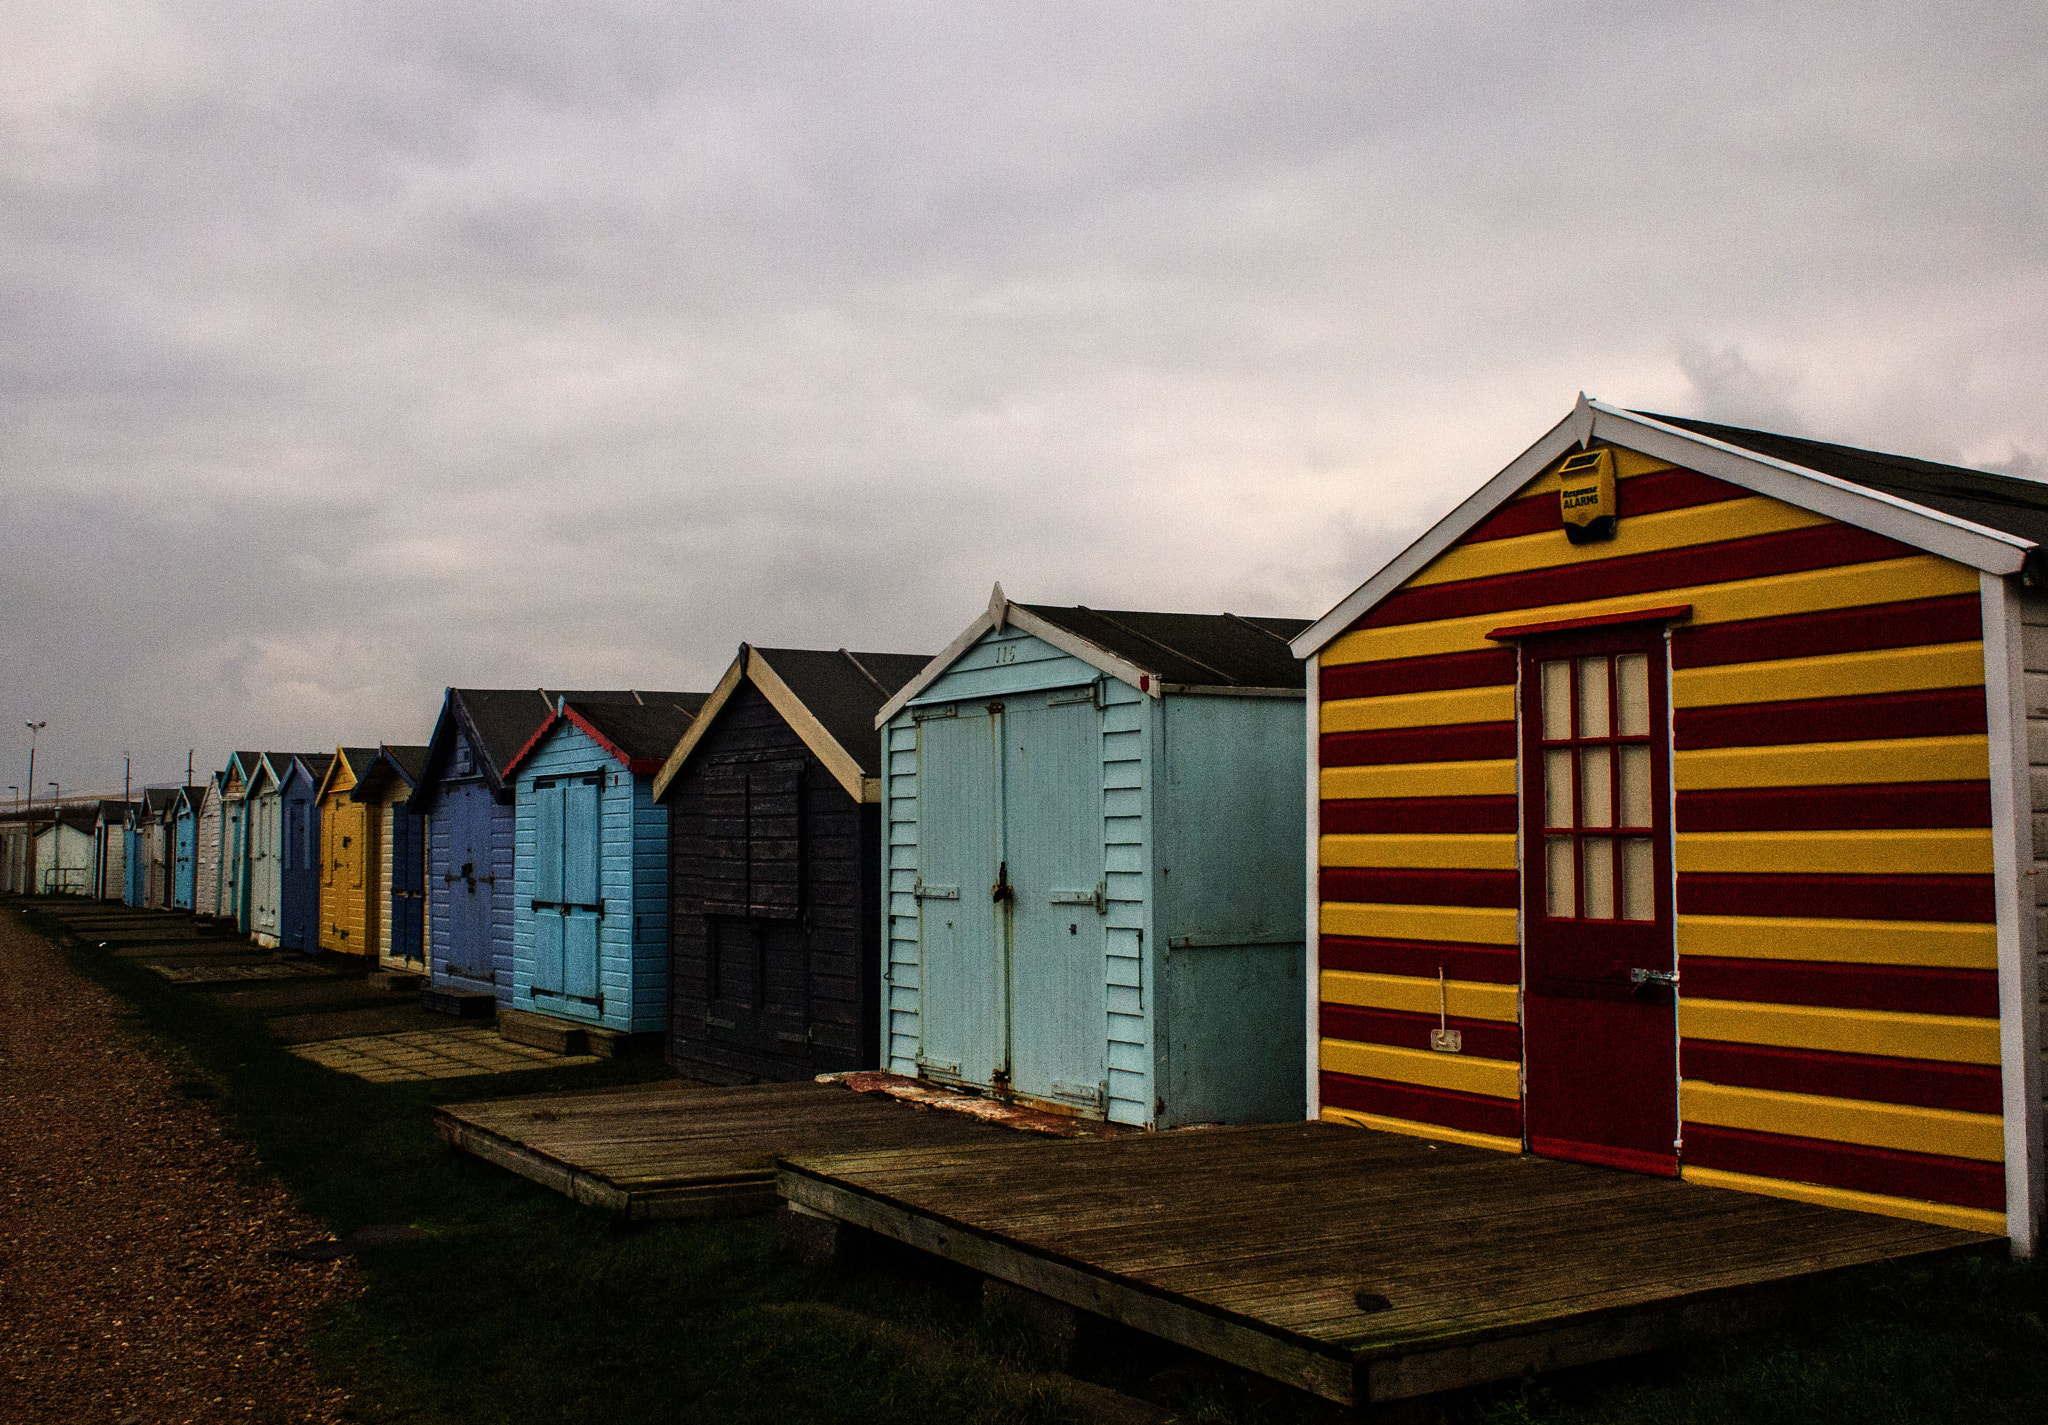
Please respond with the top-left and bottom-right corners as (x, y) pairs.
(778, 1124), (2003, 1405)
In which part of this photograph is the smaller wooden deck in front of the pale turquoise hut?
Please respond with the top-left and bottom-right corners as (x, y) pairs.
(434, 1079), (1056, 1220)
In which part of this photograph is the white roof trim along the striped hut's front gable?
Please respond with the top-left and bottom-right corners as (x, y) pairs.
(1290, 393), (2036, 659)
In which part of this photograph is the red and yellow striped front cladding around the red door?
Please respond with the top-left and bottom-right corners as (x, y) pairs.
(1317, 450), (2007, 1228)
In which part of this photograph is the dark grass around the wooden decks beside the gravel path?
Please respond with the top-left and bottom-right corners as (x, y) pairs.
(19, 917), (2048, 1425)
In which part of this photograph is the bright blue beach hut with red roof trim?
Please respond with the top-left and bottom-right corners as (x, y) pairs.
(506, 692), (711, 1038)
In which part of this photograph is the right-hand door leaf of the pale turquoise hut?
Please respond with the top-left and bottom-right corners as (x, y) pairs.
(999, 686), (1108, 1114)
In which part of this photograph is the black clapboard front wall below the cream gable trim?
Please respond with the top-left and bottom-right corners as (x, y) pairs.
(666, 680), (881, 1081)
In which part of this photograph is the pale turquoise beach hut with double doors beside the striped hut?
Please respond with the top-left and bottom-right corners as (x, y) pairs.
(877, 586), (1307, 1128)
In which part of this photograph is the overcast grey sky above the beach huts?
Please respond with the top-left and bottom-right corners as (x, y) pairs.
(0, 0), (2048, 794)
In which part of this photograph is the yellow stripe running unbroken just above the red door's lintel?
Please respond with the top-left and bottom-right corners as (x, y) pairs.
(1321, 555), (1976, 667)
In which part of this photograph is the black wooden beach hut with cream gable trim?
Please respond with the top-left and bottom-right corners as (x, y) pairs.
(653, 643), (930, 1083)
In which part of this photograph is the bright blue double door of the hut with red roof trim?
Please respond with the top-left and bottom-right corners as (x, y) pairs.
(530, 772), (604, 1011)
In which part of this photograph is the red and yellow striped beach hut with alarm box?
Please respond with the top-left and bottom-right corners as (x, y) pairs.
(1294, 397), (2048, 1251)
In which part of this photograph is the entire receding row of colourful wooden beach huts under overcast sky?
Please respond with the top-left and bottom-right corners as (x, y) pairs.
(4, 397), (2048, 1251)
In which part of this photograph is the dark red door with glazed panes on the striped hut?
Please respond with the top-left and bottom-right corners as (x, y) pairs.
(1522, 624), (1677, 1175)
